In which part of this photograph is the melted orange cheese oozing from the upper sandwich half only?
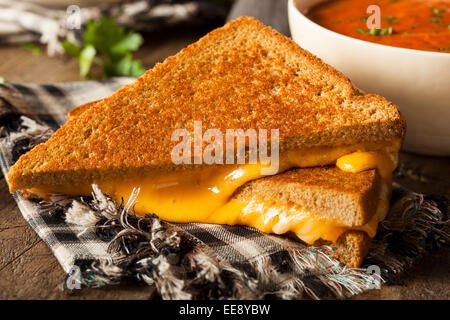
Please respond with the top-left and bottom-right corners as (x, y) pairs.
(99, 147), (395, 223)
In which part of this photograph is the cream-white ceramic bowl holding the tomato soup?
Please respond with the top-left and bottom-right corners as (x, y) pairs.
(288, 0), (450, 156)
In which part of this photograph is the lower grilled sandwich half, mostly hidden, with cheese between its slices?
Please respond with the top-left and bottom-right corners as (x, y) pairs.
(229, 167), (384, 267)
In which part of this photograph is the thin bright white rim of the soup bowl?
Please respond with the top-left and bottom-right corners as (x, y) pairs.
(288, 0), (450, 58)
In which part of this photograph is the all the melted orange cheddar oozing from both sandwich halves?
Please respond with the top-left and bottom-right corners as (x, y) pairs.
(28, 145), (398, 243)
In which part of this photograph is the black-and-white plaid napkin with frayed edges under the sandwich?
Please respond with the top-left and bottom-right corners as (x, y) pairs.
(0, 78), (450, 299)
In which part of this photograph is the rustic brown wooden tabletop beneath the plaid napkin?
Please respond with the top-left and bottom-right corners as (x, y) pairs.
(0, 27), (450, 299)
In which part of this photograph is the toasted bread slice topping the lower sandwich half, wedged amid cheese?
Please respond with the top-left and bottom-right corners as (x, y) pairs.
(233, 166), (381, 227)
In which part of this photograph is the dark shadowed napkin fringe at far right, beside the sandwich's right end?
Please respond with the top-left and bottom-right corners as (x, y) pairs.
(365, 192), (450, 283)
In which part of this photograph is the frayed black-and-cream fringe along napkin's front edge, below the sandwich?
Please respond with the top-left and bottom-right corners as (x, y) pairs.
(66, 185), (383, 299)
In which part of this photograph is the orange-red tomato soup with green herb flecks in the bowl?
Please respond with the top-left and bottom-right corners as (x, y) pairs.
(308, 0), (450, 53)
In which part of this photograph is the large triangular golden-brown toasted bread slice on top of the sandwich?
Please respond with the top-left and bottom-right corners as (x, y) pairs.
(9, 17), (405, 192)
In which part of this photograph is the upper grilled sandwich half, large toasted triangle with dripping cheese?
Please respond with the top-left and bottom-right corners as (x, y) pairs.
(8, 17), (405, 245)
